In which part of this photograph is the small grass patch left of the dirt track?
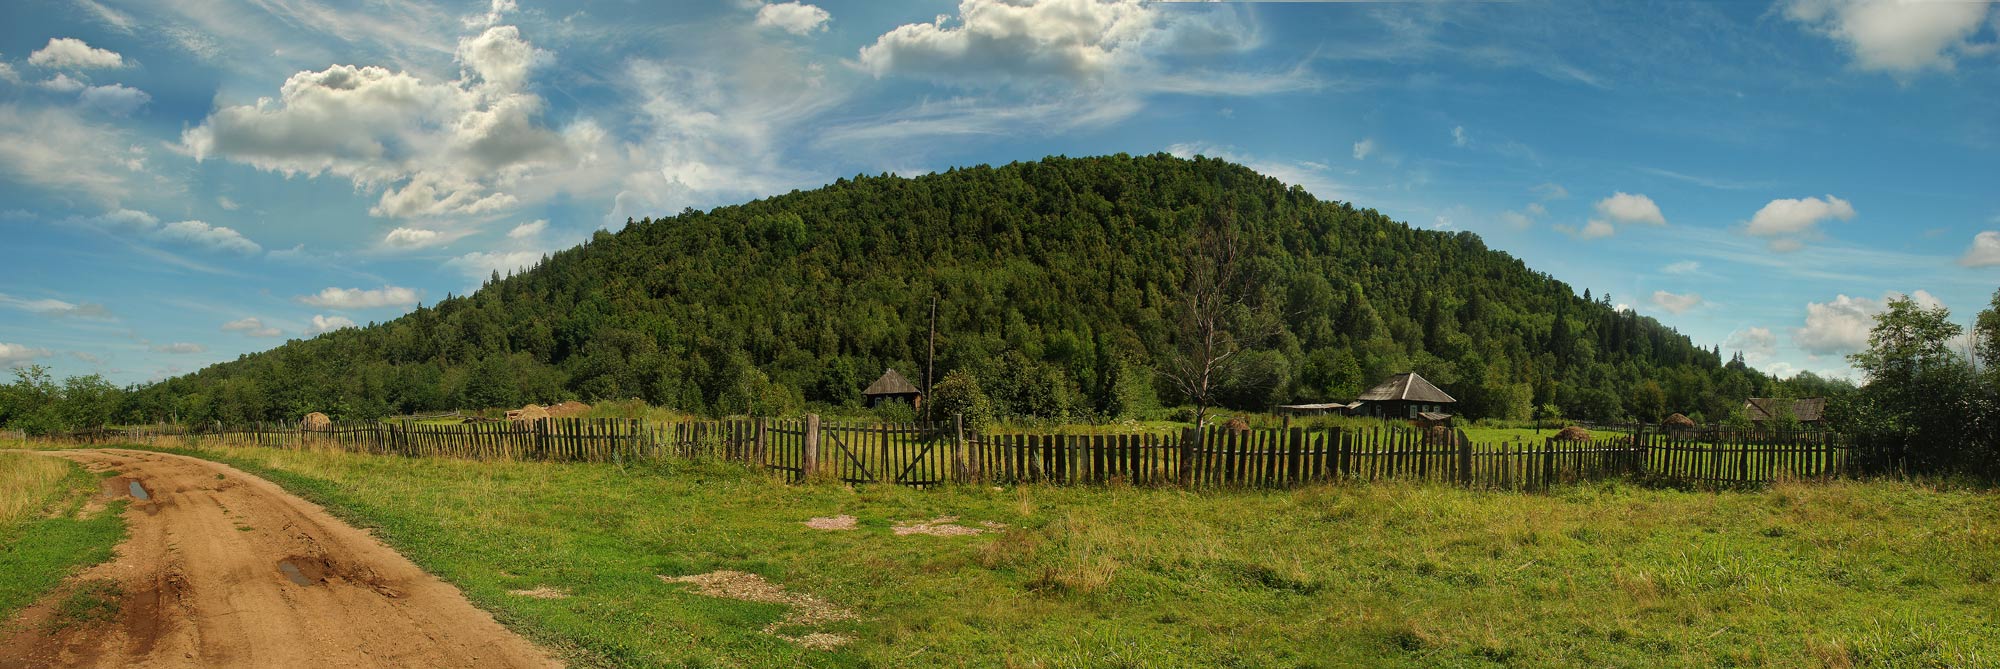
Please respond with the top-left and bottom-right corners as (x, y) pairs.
(0, 453), (124, 621)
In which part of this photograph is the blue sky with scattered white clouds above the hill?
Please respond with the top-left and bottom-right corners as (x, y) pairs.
(0, 0), (2000, 385)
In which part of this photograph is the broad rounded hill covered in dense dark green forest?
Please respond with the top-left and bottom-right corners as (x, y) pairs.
(136, 154), (1772, 421)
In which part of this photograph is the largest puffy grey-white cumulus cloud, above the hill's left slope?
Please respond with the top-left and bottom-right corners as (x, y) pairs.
(180, 26), (576, 218)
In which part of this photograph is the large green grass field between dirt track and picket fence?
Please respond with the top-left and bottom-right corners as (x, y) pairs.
(125, 438), (2000, 667)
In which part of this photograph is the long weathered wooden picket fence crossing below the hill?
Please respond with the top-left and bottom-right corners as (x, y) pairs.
(50, 417), (1898, 491)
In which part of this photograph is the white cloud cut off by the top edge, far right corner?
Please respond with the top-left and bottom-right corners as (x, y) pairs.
(1784, 0), (1990, 74)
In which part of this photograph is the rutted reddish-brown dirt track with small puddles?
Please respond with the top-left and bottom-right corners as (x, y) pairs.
(0, 451), (558, 669)
